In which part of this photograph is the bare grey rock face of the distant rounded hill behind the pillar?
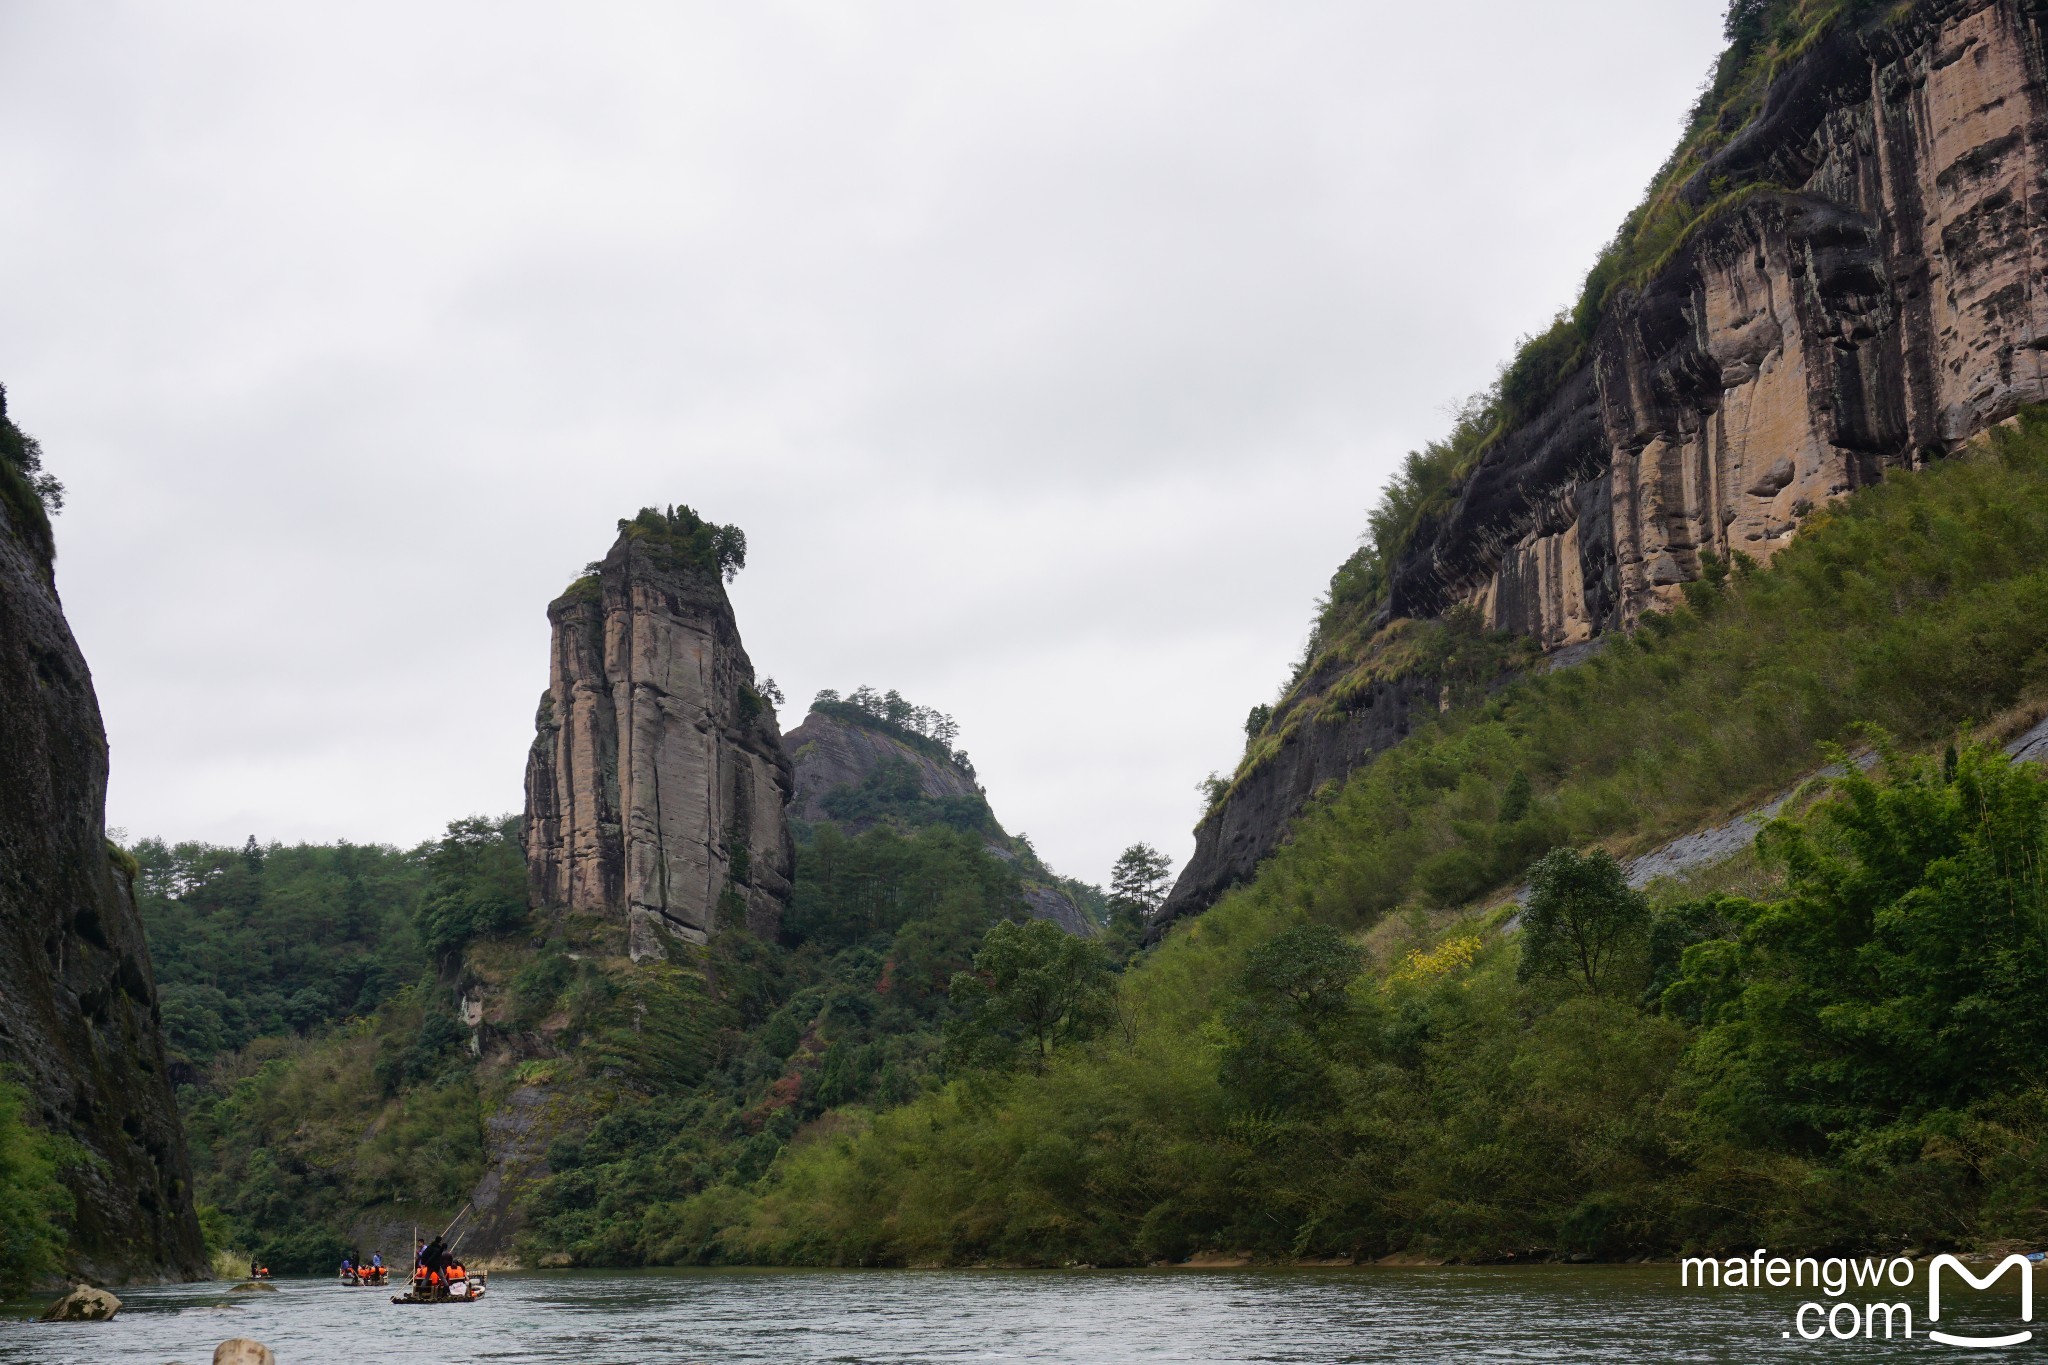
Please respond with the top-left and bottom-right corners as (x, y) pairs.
(782, 710), (1098, 937)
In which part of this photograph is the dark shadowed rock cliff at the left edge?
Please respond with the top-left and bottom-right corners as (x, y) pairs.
(0, 397), (207, 1281)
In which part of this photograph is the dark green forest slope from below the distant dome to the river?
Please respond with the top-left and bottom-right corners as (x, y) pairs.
(526, 825), (1040, 1265)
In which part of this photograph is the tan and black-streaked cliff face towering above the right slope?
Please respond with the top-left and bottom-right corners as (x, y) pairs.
(1159, 0), (2048, 927)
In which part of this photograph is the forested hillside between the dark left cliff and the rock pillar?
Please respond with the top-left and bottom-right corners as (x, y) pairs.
(133, 817), (528, 1271)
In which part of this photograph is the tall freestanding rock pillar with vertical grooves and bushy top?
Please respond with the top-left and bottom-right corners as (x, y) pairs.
(524, 524), (795, 960)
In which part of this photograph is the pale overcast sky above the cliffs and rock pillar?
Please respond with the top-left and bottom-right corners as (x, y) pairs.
(0, 0), (1722, 880)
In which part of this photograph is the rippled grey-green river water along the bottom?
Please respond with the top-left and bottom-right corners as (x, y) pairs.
(0, 1265), (2015, 1365)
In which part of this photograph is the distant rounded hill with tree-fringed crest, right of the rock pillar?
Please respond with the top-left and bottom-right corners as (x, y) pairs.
(782, 688), (1102, 935)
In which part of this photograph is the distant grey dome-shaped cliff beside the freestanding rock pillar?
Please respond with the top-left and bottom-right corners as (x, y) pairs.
(782, 706), (1100, 937)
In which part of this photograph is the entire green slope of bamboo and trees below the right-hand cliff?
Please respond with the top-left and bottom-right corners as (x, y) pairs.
(676, 413), (2048, 1265)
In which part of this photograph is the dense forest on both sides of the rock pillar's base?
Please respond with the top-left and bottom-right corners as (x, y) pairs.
(140, 716), (1110, 1271)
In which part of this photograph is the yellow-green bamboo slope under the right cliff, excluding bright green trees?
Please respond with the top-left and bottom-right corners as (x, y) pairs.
(688, 411), (2048, 1265)
